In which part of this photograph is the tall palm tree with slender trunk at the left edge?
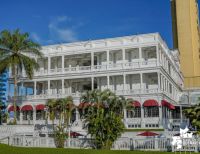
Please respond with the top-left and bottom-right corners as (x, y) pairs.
(0, 29), (43, 122)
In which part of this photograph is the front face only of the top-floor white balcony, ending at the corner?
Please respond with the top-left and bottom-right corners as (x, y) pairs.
(14, 46), (159, 77)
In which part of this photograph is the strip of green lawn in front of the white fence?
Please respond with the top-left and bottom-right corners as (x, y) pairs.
(0, 144), (177, 154)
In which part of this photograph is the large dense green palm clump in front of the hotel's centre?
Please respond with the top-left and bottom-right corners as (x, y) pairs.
(81, 90), (129, 149)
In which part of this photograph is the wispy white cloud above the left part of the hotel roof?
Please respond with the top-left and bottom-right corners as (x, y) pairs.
(48, 16), (78, 42)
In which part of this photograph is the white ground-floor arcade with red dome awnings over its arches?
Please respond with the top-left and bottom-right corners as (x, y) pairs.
(8, 99), (188, 129)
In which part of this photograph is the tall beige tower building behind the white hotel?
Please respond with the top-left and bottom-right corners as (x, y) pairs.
(171, 0), (200, 88)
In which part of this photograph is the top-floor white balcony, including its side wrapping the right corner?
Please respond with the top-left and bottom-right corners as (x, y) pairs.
(10, 45), (183, 92)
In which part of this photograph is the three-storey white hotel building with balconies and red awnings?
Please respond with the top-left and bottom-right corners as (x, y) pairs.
(8, 33), (189, 129)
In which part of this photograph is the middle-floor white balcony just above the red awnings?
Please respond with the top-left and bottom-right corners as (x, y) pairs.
(7, 72), (178, 103)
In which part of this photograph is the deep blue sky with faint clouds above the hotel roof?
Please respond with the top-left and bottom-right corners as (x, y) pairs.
(0, 0), (197, 47)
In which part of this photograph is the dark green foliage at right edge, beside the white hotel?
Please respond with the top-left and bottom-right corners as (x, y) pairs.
(184, 104), (200, 134)
